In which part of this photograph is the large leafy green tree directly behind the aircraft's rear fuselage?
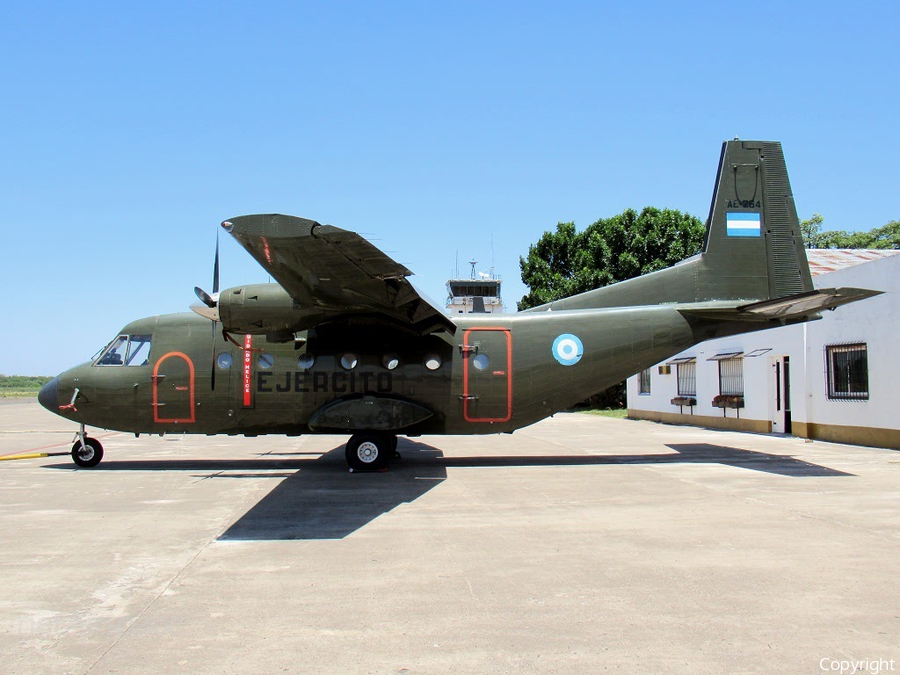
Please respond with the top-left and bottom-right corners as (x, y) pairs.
(518, 207), (706, 408)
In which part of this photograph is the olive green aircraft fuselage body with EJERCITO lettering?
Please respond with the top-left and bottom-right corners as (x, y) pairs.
(58, 306), (716, 435)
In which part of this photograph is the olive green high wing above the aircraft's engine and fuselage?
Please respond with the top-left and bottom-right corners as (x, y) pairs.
(222, 214), (456, 335)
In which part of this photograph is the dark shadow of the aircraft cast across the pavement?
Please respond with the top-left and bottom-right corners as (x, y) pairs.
(42, 438), (853, 541)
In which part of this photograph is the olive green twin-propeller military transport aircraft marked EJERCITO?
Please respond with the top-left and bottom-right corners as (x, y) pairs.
(39, 140), (877, 470)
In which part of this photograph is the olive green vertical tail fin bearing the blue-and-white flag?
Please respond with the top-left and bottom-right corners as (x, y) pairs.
(529, 139), (813, 311)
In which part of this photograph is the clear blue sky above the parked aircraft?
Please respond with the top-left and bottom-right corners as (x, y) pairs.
(0, 2), (900, 374)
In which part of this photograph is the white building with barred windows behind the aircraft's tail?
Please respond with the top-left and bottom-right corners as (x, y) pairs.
(627, 249), (900, 449)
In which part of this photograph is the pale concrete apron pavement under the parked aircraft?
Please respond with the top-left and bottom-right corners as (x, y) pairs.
(0, 402), (900, 675)
